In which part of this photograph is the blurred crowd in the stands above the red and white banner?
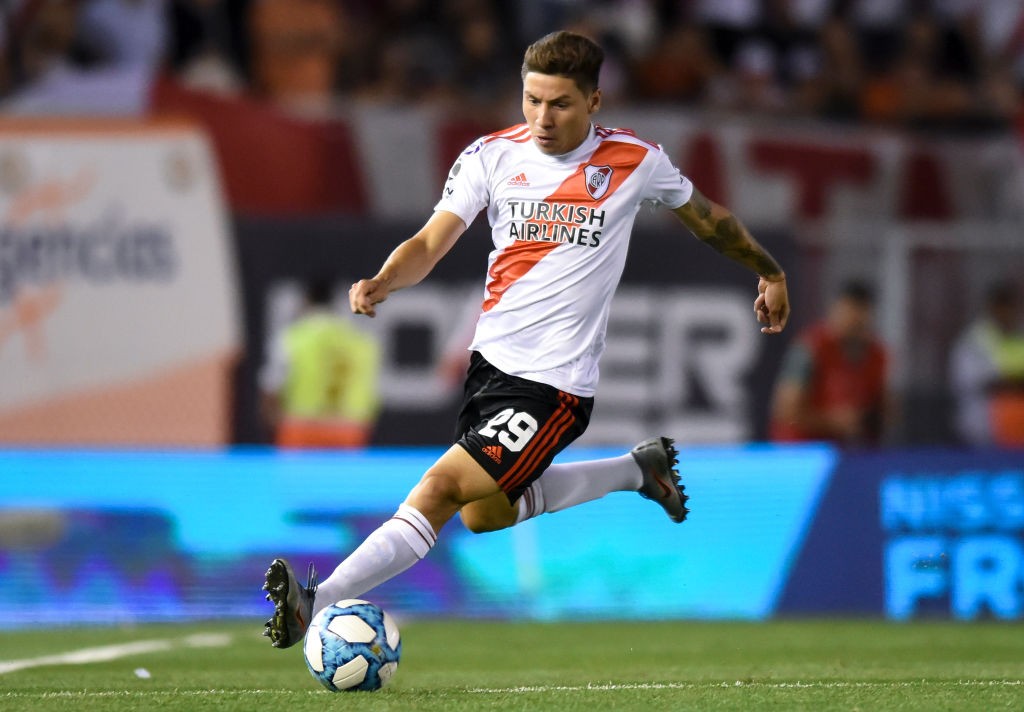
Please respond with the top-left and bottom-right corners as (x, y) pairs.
(6, 0), (1024, 131)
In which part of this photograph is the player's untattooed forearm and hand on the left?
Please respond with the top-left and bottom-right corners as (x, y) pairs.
(348, 210), (466, 317)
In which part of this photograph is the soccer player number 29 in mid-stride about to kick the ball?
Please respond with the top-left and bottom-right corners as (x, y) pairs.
(264, 32), (790, 647)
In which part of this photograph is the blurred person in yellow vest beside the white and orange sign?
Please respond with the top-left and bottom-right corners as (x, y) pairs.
(260, 281), (380, 448)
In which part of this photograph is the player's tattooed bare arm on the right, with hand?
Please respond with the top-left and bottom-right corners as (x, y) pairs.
(673, 187), (790, 334)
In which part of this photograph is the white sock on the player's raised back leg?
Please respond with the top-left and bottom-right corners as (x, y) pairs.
(516, 455), (643, 523)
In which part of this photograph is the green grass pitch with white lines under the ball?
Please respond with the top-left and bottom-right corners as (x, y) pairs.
(0, 620), (1024, 712)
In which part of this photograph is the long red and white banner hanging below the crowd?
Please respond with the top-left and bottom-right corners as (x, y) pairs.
(154, 82), (1024, 226)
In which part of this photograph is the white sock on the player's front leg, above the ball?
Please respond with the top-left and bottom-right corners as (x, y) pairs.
(313, 504), (437, 616)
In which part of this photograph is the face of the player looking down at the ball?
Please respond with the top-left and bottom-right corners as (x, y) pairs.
(522, 72), (601, 156)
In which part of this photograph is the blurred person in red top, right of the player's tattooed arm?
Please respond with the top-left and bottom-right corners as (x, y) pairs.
(770, 281), (889, 446)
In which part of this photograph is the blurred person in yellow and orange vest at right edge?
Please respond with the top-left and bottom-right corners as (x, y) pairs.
(950, 282), (1024, 446)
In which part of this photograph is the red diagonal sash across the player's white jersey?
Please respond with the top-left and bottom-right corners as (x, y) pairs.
(483, 141), (647, 311)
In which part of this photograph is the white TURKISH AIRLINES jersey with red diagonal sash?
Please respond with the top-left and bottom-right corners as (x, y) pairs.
(434, 124), (693, 396)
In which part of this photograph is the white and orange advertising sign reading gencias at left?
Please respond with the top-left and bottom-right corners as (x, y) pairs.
(0, 121), (241, 445)
